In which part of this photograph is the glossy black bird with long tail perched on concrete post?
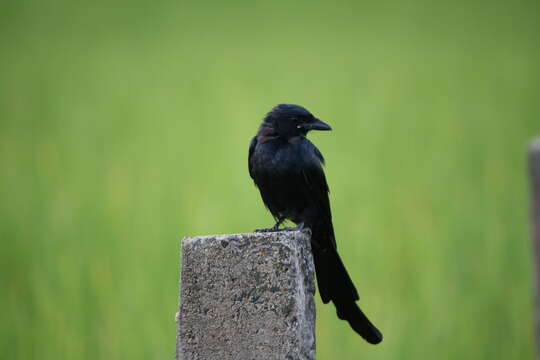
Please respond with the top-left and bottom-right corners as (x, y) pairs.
(248, 104), (383, 344)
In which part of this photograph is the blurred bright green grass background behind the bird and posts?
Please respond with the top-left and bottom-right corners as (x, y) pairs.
(0, 0), (540, 360)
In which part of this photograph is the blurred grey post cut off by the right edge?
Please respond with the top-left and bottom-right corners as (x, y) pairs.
(529, 138), (540, 359)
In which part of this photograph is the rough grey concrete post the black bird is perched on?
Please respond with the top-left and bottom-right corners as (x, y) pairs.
(176, 231), (315, 360)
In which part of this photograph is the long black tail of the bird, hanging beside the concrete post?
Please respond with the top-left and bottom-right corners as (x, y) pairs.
(313, 235), (383, 344)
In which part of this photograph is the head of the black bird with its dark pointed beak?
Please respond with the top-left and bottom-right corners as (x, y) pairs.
(263, 104), (332, 138)
